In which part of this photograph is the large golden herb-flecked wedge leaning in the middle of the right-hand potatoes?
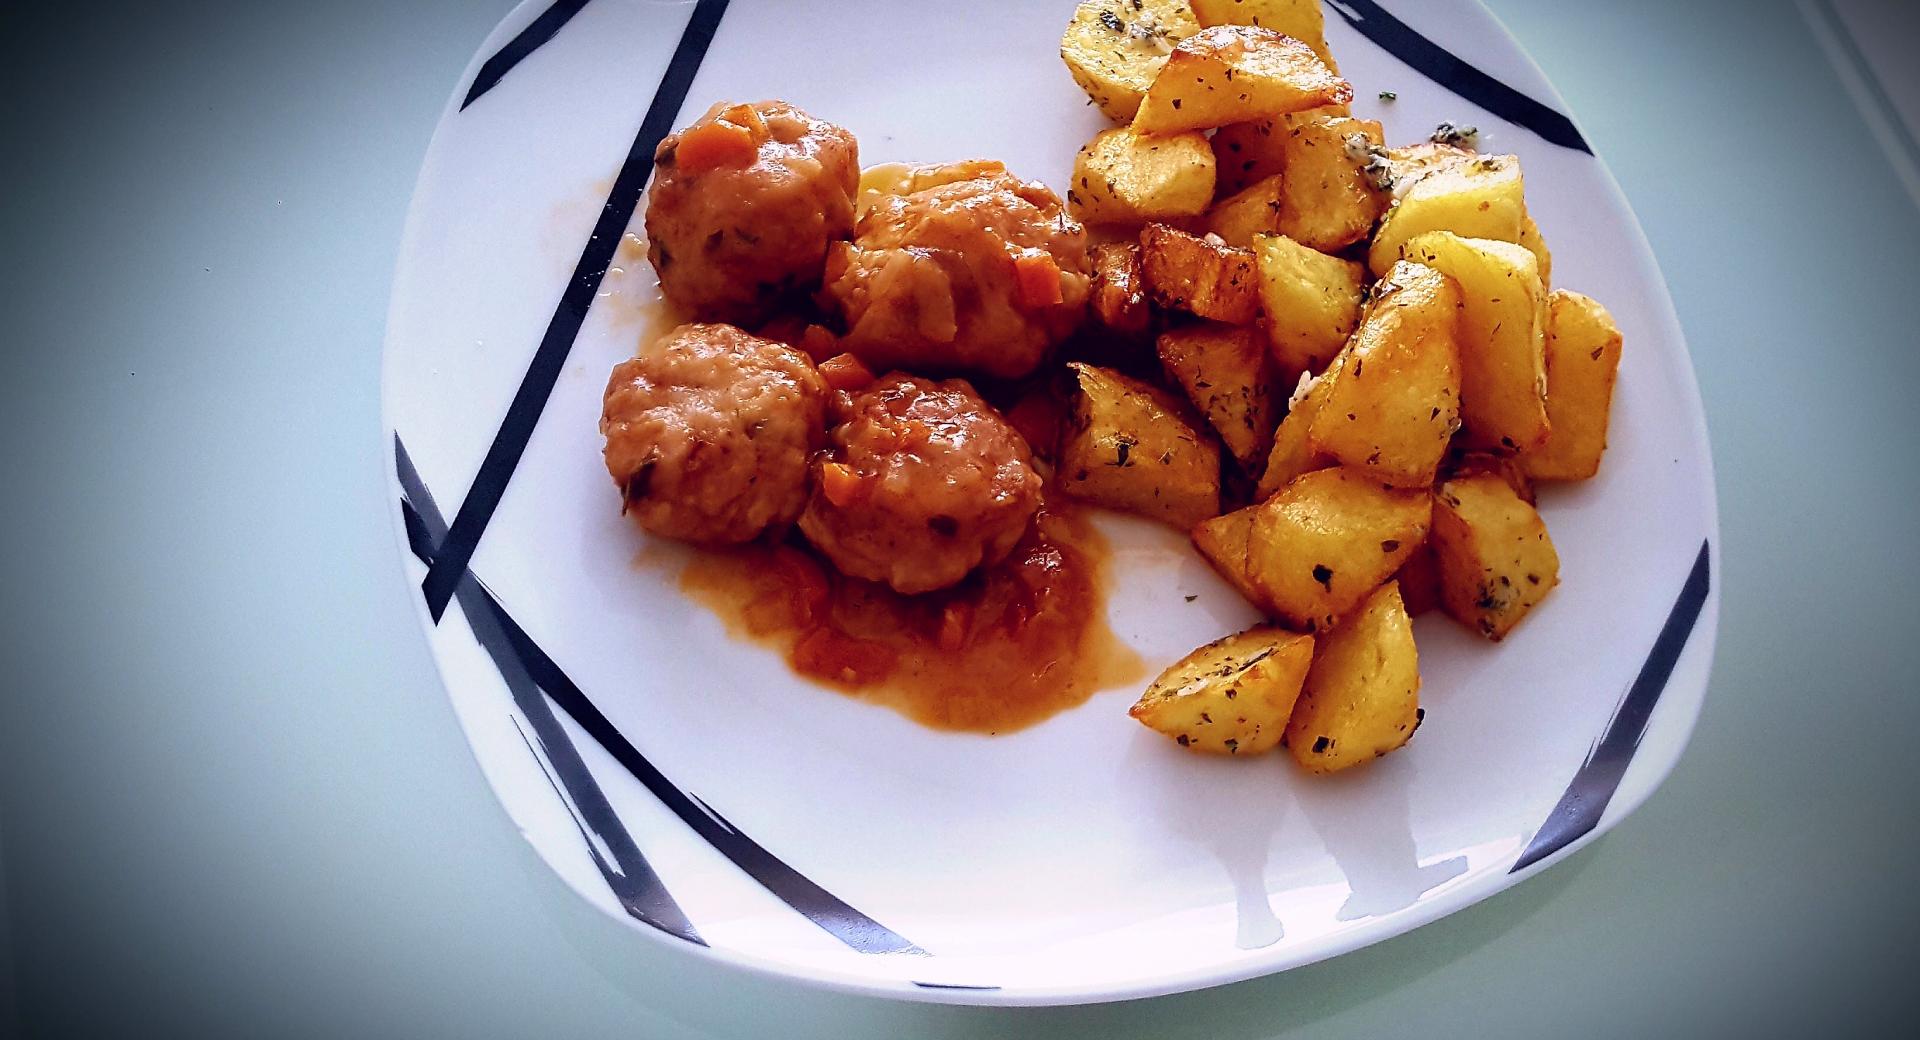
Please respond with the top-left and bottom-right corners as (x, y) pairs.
(1308, 261), (1461, 487)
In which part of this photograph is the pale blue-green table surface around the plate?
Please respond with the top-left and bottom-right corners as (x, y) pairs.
(0, 0), (1920, 1040)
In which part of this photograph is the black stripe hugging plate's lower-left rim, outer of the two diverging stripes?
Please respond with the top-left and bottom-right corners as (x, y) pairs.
(394, 434), (707, 946)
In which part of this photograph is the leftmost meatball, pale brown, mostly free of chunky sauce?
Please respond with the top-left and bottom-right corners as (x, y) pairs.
(601, 324), (829, 543)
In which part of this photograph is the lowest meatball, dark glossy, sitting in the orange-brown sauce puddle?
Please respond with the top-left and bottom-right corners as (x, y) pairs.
(801, 372), (1041, 593)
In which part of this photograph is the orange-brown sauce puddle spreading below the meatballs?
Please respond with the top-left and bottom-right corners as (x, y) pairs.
(680, 505), (1144, 733)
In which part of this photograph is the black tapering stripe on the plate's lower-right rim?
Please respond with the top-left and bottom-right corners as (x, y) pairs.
(1507, 541), (1711, 873)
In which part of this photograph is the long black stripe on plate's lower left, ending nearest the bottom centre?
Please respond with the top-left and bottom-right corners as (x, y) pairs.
(394, 436), (925, 956)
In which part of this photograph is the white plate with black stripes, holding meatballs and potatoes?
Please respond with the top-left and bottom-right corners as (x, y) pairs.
(384, 0), (1718, 1004)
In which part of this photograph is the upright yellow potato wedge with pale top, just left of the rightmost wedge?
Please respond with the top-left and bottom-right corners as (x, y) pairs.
(1402, 230), (1549, 453)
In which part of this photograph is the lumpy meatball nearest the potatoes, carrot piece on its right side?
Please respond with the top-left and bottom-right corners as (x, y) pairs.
(822, 171), (1091, 378)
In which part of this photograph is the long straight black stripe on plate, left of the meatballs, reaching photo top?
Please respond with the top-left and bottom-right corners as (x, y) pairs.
(420, 0), (726, 624)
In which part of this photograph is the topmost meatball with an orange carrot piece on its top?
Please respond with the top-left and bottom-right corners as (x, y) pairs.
(647, 102), (860, 324)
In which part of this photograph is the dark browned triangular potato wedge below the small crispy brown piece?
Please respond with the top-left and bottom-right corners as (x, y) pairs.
(1156, 322), (1281, 474)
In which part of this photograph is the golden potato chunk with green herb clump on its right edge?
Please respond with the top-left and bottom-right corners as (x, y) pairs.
(1279, 115), (1388, 253)
